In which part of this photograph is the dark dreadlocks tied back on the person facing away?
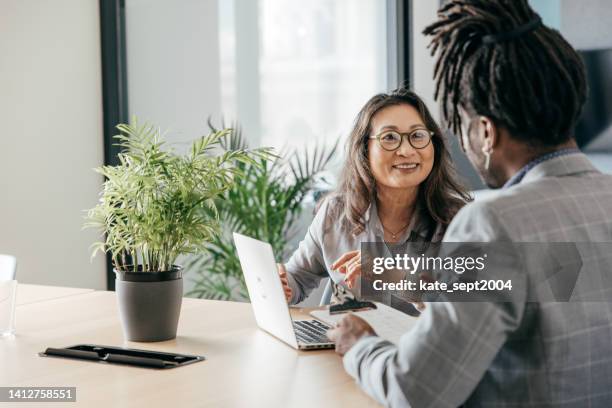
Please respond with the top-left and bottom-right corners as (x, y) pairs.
(423, 0), (587, 147)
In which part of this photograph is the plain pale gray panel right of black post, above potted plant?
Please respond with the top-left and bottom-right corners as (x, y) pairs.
(125, 0), (221, 150)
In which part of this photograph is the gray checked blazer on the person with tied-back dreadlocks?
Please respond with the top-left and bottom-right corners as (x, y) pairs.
(344, 153), (612, 407)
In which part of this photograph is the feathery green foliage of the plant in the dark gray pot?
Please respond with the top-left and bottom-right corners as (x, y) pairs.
(85, 120), (270, 271)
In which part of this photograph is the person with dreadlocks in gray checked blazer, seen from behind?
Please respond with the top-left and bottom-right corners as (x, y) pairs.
(328, 0), (612, 407)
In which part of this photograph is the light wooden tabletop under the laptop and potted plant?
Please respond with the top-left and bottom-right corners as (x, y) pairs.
(0, 285), (378, 408)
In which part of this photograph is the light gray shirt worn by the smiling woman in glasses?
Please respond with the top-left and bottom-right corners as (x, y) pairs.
(285, 196), (444, 304)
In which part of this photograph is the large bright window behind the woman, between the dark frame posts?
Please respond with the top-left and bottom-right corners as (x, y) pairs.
(125, 0), (390, 153)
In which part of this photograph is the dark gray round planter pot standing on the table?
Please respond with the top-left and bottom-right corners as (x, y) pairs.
(115, 266), (183, 341)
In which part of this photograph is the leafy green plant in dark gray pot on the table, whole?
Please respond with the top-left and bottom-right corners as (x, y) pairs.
(85, 121), (269, 341)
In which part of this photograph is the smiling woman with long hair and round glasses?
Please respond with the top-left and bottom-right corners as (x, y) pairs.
(279, 89), (470, 303)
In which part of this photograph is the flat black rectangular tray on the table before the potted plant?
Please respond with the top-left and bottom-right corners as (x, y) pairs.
(38, 344), (206, 369)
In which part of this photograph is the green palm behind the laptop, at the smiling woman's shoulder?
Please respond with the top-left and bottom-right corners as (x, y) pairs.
(185, 123), (337, 300)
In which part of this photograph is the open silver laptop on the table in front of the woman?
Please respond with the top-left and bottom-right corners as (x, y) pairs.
(234, 233), (334, 350)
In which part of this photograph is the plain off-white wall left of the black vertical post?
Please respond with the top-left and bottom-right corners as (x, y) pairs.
(0, 0), (105, 289)
